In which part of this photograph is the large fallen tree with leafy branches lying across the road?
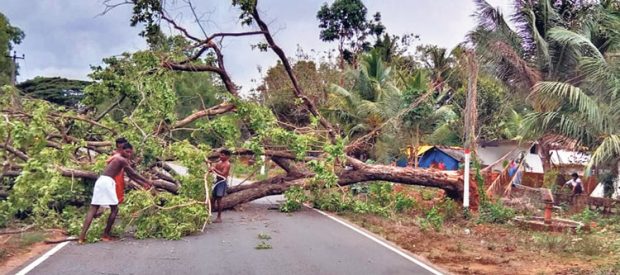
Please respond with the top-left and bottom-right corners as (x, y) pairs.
(0, 0), (477, 238)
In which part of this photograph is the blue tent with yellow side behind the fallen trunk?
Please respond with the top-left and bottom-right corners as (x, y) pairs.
(418, 146), (465, 171)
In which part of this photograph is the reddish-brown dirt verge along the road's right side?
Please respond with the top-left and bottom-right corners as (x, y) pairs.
(342, 214), (619, 274)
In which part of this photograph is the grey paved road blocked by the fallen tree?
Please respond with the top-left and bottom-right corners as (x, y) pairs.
(14, 199), (440, 275)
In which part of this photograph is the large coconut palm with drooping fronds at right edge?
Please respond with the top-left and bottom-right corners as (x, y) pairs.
(469, 0), (620, 168)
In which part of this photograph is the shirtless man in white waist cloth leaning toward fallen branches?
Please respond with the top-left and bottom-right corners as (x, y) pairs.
(78, 143), (152, 244)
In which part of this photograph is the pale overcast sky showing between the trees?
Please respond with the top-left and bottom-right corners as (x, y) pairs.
(0, 0), (512, 90)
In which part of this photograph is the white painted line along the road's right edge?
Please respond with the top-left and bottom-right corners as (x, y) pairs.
(308, 207), (449, 275)
